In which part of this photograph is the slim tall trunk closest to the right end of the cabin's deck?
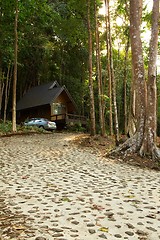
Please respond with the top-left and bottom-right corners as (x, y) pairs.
(87, 0), (96, 136)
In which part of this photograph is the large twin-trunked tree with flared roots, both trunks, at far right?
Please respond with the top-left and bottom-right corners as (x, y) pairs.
(109, 0), (160, 161)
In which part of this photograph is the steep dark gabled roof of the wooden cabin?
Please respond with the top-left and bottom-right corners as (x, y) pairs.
(17, 81), (75, 110)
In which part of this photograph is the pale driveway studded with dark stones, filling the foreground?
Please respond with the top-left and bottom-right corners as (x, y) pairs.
(0, 133), (160, 240)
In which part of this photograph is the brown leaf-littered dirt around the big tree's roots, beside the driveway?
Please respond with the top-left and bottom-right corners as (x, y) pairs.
(75, 135), (160, 171)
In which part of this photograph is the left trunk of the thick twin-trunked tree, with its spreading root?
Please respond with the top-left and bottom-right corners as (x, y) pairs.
(110, 0), (146, 154)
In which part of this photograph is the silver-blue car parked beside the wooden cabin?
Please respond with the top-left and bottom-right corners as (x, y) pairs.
(24, 118), (57, 131)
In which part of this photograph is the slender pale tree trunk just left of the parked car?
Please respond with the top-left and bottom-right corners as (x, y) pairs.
(12, 0), (18, 132)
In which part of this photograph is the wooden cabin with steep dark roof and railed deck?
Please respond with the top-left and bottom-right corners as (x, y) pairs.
(17, 81), (85, 128)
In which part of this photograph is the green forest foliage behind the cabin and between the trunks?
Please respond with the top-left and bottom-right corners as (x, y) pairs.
(0, 0), (160, 137)
